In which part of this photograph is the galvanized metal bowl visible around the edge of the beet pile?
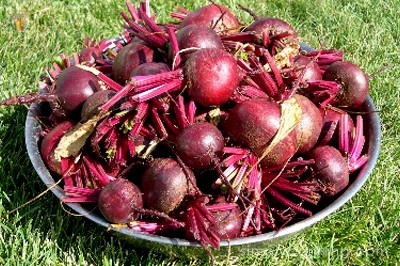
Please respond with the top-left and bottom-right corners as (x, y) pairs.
(25, 47), (381, 255)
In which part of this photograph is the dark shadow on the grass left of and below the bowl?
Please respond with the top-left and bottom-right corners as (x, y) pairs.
(0, 106), (211, 265)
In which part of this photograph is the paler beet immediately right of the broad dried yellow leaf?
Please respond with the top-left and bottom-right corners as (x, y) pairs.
(294, 94), (322, 153)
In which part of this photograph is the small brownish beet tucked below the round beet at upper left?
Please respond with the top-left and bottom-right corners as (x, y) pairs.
(81, 90), (116, 120)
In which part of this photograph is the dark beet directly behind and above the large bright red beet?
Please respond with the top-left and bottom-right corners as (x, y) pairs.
(174, 25), (224, 62)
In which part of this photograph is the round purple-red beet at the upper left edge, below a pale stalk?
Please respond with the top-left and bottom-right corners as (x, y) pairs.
(54, 66), (101, 117)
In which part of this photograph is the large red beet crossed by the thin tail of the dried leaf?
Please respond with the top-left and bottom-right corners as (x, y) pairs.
(224, 99), (297, 167)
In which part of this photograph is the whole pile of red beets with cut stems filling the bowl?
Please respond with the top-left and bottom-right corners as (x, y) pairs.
(1, 1), (369, 249)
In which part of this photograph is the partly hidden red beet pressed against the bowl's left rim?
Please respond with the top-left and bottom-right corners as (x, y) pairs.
(40, 121), (75, 175)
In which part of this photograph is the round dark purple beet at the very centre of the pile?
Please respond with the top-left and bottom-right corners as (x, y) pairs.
(175, 122), (225, 170)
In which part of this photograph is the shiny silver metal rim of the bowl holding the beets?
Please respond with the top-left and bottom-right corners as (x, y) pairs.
(25, 45), (382, 247)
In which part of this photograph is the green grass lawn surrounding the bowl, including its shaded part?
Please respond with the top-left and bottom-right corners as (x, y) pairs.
(0, 0), (400, 265)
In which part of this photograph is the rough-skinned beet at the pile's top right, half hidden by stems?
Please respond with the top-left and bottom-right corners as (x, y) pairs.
(246, 18), (299, 44)
